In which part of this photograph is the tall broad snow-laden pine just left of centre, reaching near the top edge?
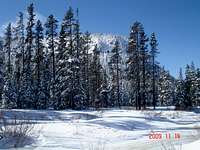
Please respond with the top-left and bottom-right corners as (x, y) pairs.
(57, 7), (79, 109)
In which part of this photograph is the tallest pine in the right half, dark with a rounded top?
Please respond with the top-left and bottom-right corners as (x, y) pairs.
(127, 22), (144, 109)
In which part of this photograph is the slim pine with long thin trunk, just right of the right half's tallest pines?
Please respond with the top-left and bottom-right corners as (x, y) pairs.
(150, 33), (158, 109)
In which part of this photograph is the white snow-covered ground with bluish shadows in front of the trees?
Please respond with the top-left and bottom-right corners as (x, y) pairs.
(0, 109), (200, 150)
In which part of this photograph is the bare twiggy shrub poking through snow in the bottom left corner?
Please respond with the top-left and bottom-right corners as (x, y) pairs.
(0, 112), (34, 148)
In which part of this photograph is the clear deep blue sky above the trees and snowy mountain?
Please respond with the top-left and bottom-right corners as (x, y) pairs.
(0, 0), (200, 76)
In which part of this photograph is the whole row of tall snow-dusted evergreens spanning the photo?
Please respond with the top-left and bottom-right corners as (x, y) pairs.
(0, 4), (200, 110)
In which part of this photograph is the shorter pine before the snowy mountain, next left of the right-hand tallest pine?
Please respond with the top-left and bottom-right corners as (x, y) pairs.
(109, 41), (122, 107)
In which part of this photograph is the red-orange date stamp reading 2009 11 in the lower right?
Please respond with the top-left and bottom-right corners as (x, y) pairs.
(149, 132), (181, 140)
